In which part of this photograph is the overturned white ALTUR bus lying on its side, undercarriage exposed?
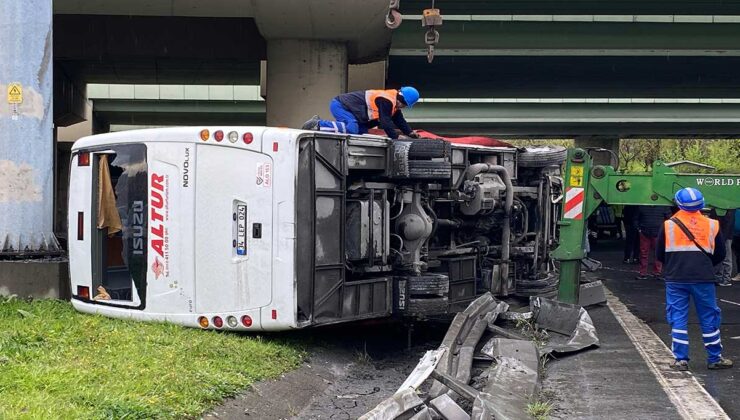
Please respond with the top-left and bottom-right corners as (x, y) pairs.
(69, 127), (557, 331)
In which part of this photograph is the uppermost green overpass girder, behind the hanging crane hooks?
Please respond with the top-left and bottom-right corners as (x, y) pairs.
(391, 20), (740, 56)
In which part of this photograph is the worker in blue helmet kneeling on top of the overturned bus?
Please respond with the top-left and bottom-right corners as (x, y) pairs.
(302, 86), (419, 139)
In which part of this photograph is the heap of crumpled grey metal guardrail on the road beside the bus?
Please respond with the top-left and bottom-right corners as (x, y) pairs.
(360, 294), (599, 420)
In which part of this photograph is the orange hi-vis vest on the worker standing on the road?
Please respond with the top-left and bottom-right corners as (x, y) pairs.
(664, 210), (719, 254)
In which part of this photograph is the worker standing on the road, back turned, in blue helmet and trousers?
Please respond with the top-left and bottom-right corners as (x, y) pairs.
(656, 188), (733, 371)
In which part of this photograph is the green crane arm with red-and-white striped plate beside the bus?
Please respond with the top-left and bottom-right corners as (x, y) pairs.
(553, 149), (740, 303)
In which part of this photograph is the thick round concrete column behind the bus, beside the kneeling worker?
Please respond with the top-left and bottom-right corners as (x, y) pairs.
(266, 39), (347, 128)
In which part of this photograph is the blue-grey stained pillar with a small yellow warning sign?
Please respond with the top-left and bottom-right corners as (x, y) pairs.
(0, 0), (57, 256)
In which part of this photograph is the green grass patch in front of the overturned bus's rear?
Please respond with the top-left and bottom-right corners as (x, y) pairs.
(0, 298), (303, 419)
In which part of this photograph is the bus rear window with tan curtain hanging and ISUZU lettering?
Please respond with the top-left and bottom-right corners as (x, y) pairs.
(92, 144), (148, 308)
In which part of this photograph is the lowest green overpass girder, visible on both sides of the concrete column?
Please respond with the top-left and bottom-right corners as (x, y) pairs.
(93, 99), (740, 138)
